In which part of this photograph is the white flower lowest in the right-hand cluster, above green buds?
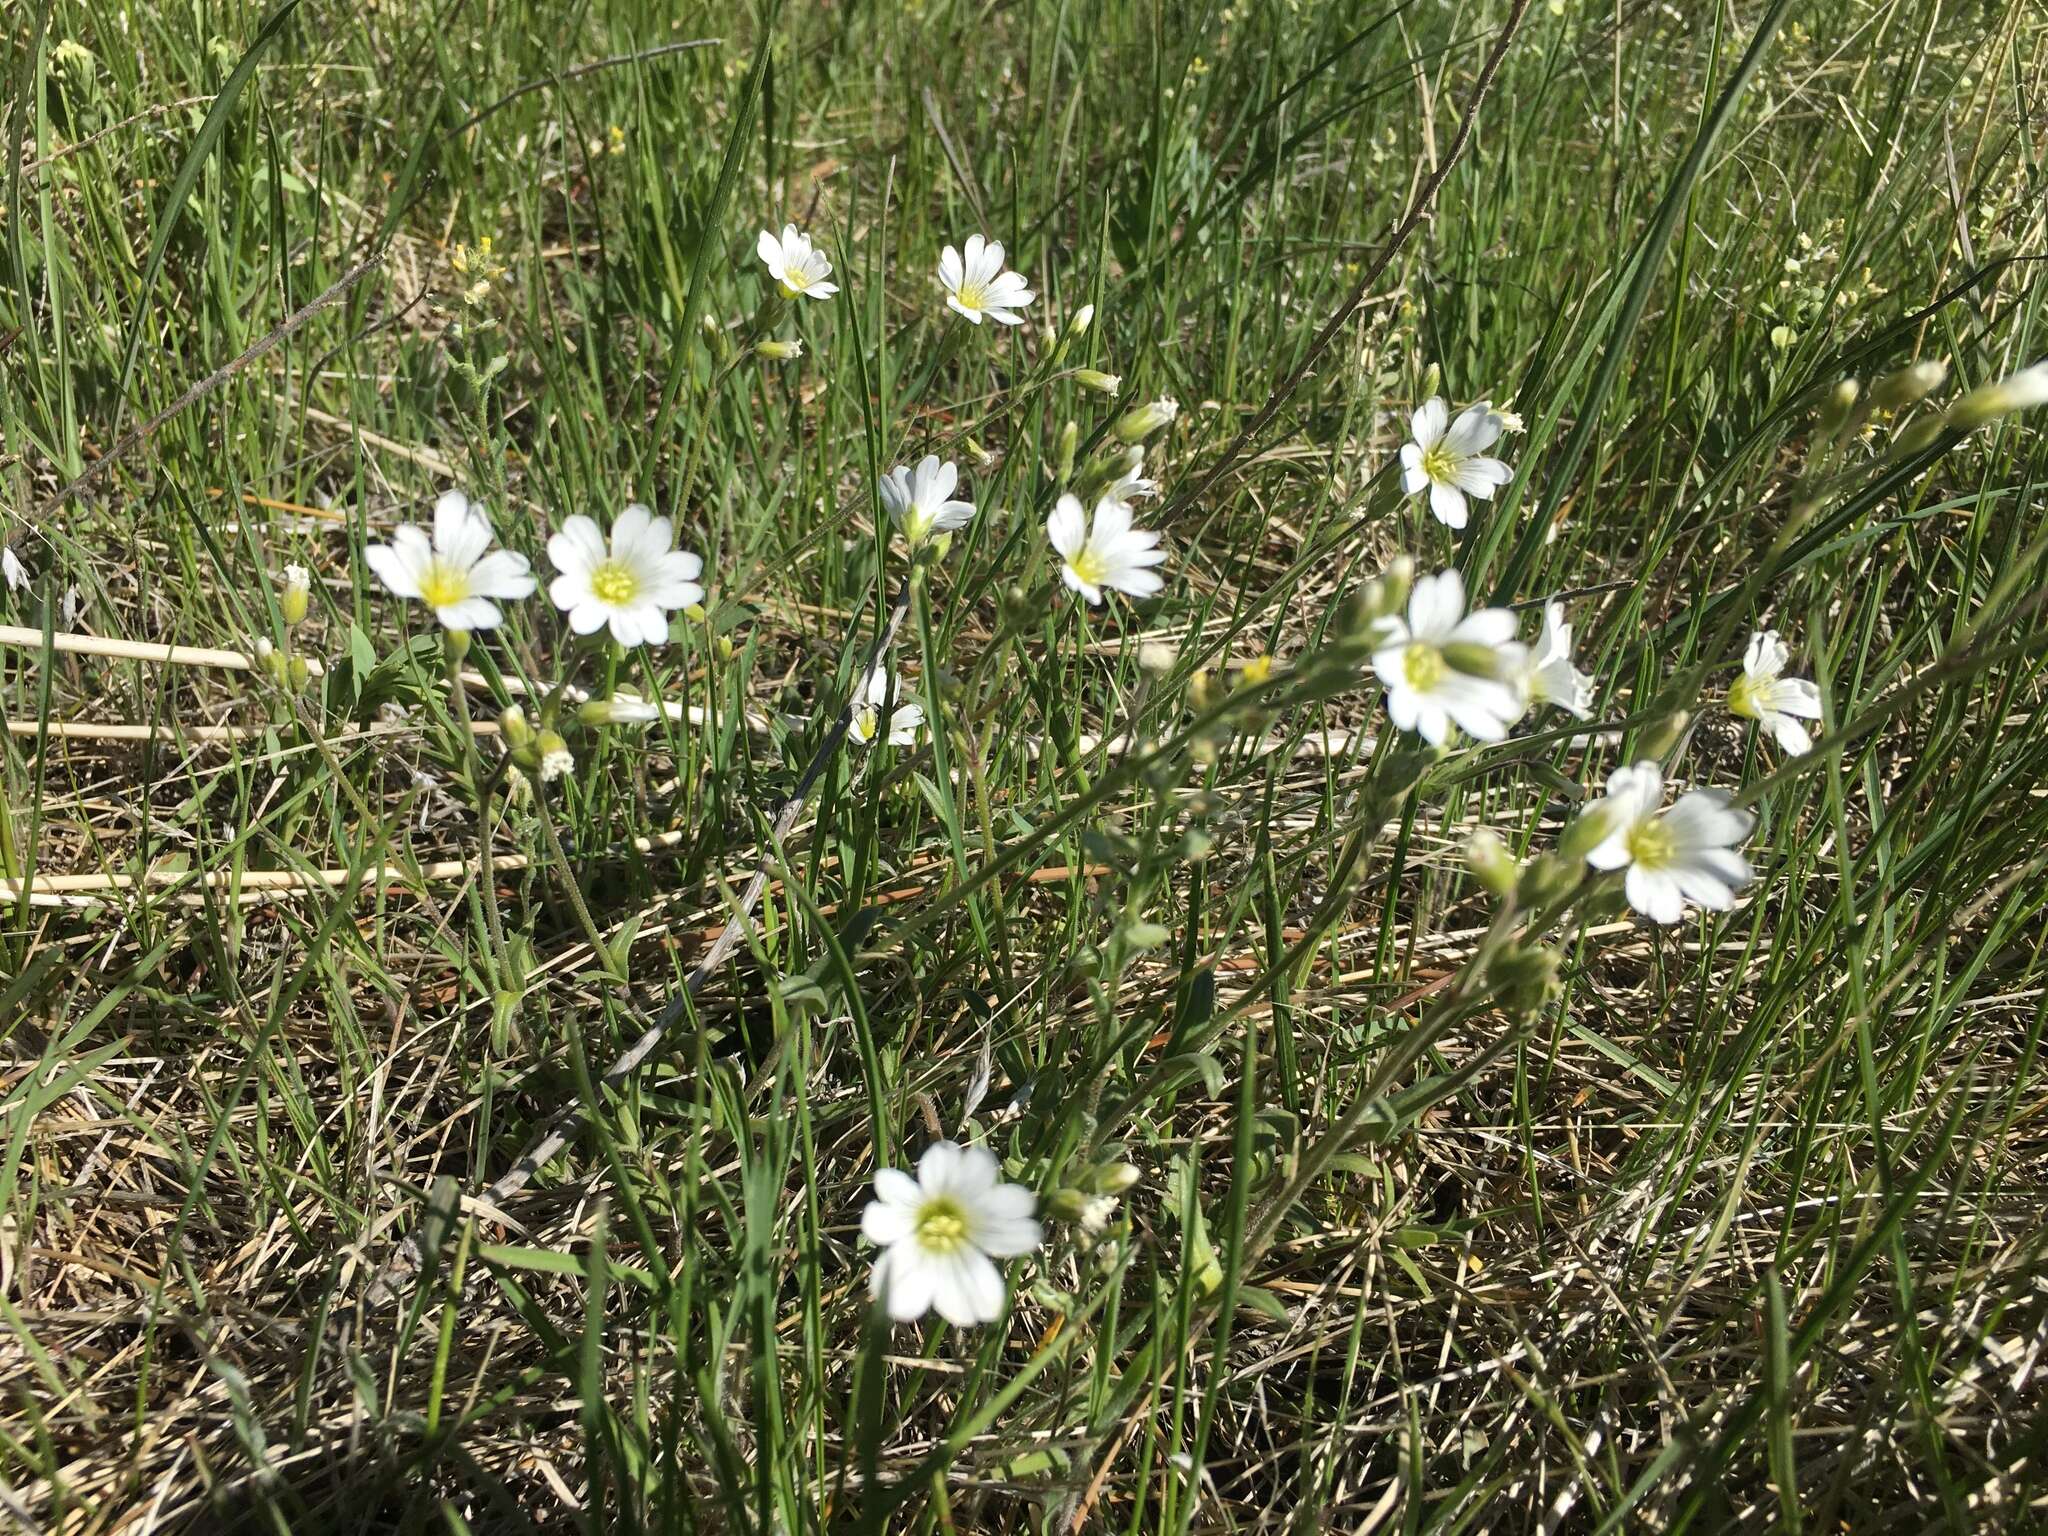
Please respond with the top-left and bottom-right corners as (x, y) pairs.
(1585, 762), (1755, 924)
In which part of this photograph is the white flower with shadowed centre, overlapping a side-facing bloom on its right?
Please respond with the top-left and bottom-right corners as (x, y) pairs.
(1372, 571), (1528, 745)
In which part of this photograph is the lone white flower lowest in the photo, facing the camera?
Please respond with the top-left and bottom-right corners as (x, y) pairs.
(860, 1141), (1044, 1327)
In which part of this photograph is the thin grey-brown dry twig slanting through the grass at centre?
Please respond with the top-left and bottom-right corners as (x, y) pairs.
(367, 582), (911, 1307)
